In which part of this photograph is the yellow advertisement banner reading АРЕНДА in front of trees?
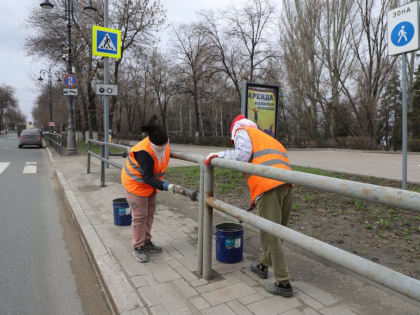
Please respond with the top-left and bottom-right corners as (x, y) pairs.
(246, 86), (277, 138)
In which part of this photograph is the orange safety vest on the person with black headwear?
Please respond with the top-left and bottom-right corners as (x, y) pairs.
(121, 137), (170, 197)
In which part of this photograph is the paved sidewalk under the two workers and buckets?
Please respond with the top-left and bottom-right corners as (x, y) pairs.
(46, 149), (420, 315)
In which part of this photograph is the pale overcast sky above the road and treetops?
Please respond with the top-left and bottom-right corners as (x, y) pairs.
(0, 0), (243, 120)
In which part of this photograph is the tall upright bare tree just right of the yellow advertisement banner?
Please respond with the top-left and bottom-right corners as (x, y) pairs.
(281, 0), (323, 139)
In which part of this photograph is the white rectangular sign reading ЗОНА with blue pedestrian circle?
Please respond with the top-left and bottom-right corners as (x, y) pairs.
(388, 1), (420, 55)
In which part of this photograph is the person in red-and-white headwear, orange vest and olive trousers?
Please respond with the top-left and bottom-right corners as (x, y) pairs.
(205, 115), (293, 297)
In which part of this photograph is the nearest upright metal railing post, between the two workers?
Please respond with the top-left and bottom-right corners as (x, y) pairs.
(203, 165), (213, 280)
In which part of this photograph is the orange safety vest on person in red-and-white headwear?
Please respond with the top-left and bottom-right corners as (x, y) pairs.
(238, 127), (290, 205)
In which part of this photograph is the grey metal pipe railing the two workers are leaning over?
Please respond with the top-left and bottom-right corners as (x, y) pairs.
(88, 140), (420, 301)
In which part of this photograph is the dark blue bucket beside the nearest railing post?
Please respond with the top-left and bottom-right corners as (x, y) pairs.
(216, 223), (244, 264)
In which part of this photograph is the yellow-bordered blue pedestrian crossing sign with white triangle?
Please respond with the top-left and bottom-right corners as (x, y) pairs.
(92, 25), (121, 59)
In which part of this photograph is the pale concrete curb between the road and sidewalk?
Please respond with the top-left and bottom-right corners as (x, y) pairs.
(46, 147), (149, 315)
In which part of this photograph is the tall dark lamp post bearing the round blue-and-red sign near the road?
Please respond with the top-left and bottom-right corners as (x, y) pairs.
(40, 0), (77, 155)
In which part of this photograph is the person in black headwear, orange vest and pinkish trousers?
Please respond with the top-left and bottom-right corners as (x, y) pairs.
(121, 116), (182, 263)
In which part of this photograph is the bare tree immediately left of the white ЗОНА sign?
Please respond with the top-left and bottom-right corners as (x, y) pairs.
(340, 0), (395, 139)
